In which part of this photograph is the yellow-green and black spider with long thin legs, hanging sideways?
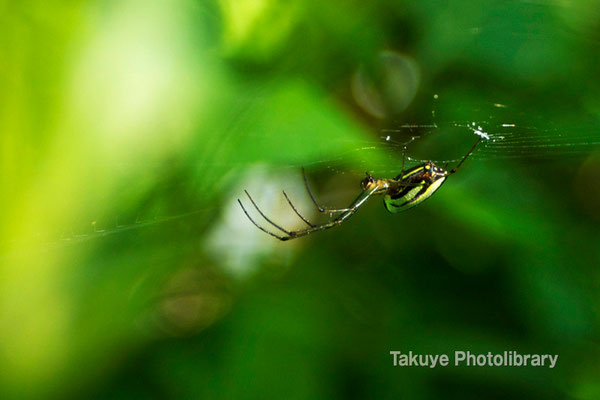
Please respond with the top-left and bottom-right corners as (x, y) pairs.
(238, 137), (483, 241)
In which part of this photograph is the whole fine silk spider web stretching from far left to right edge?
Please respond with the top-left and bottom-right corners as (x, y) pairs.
(12, 99), (600, 247)
